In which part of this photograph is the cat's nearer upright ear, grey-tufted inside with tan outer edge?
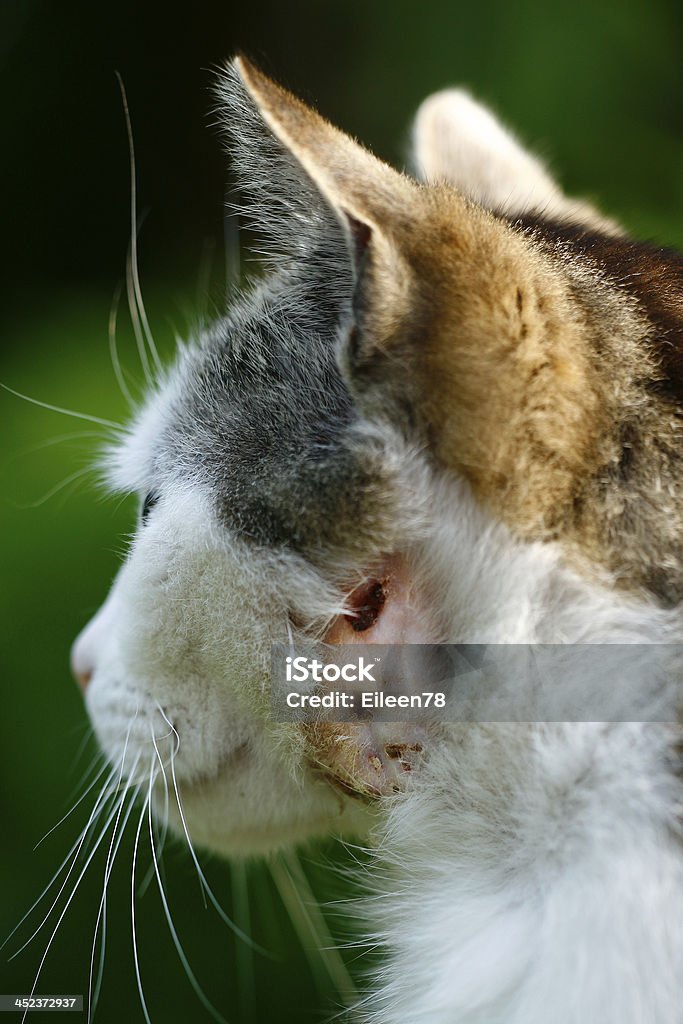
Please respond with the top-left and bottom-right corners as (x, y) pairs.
(219, 57), (421, 376)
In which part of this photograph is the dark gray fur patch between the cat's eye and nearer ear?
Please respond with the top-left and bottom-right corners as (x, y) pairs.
(148, 260), (393, 552)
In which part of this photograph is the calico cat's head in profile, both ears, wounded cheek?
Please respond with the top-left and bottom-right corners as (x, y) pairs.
(73, 60), (683, 853)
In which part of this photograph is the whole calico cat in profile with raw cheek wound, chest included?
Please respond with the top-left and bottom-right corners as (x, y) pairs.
(73, 58), (683, 1024)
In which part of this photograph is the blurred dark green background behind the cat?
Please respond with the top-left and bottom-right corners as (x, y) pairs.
(0, 0), (683, 1024)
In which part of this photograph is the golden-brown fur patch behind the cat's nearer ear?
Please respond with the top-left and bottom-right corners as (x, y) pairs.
(354, 187), (683, 604)
